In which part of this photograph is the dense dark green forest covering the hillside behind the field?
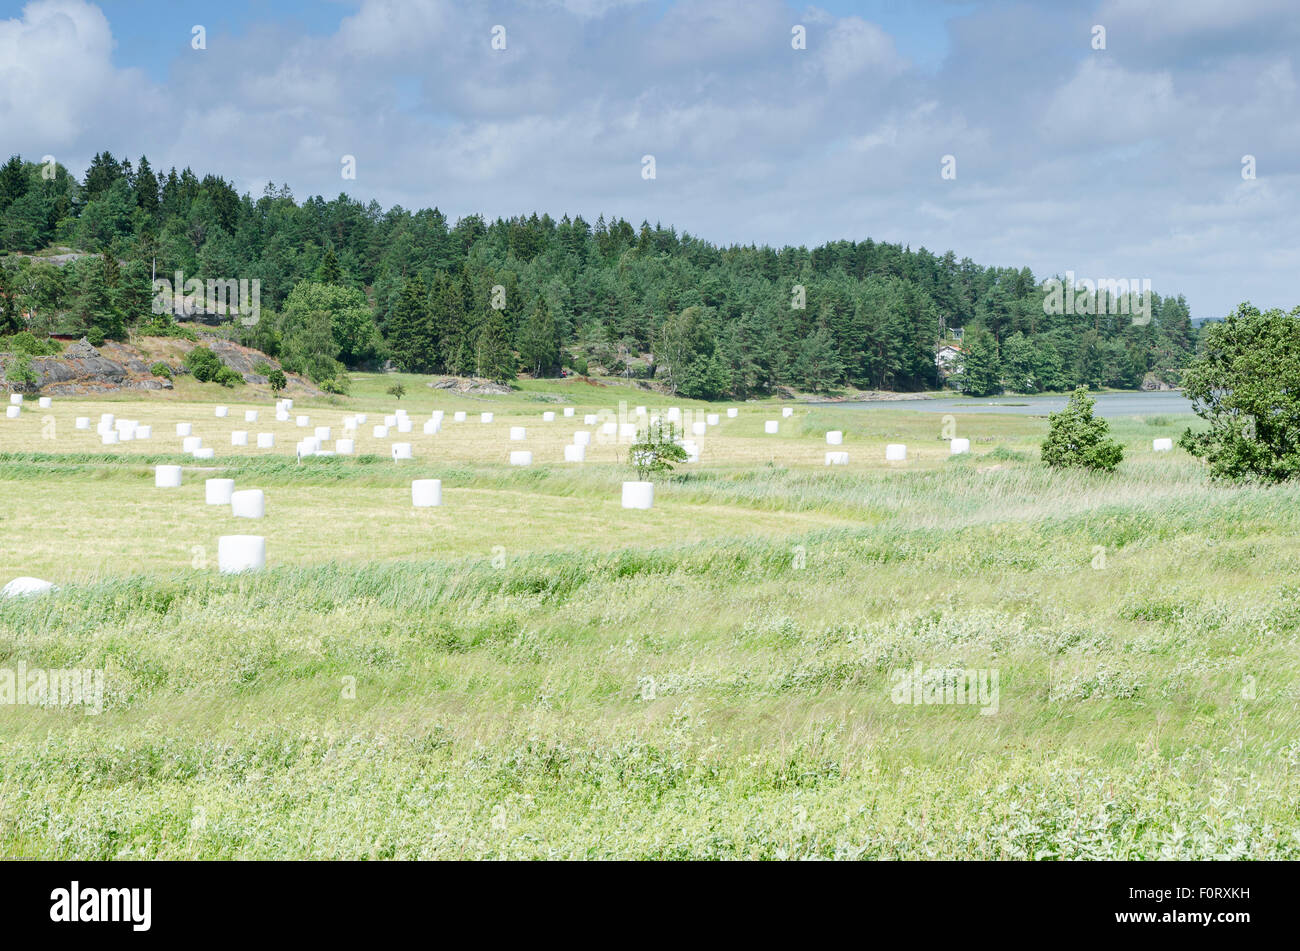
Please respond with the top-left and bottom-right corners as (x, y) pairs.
(0, 152), (1197, 399)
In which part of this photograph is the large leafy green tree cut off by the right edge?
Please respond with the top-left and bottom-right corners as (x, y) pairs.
(1178, 303), (1300, 482)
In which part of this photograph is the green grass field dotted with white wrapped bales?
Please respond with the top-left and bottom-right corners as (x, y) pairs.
(0, 377), (1300, 859)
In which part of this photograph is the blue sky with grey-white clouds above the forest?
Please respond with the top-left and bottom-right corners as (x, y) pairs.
(0, 0), (1300, 317)
